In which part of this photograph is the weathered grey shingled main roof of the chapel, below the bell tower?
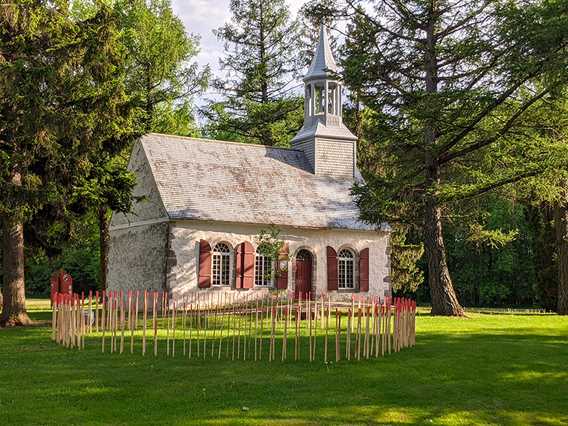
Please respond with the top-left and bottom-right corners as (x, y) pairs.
(141, 134), (374, 230)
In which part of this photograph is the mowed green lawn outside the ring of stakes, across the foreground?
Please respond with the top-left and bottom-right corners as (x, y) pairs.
(0, 302), (568, 425)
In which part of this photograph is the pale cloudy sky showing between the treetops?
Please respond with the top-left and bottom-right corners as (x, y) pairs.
(172, 0), (305, 80)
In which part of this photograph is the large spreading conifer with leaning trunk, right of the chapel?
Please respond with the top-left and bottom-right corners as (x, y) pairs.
(310, 0), (568, 315)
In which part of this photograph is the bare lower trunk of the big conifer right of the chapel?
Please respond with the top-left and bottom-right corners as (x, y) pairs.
(424, 191), (464, 316)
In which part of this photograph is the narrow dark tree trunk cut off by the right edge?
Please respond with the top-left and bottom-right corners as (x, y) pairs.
(554, 204), (568, 315)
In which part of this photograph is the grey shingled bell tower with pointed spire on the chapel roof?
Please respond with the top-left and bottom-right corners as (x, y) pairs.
(292, 24), (357, 180)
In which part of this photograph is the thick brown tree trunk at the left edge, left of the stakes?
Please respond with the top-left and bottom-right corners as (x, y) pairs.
(0, 216), (32, 327)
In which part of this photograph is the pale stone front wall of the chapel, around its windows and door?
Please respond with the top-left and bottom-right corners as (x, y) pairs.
(162, 221), (391, 300)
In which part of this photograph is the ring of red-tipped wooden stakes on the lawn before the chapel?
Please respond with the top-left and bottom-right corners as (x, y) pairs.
(52, 291), (416, 362)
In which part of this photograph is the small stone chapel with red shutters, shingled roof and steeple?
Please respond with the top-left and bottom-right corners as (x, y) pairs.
(108, 26), (391, 300)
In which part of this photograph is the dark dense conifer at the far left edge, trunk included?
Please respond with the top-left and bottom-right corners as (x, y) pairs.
(0, 0), (134, 325)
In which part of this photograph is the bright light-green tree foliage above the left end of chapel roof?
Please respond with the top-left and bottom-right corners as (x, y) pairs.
(114, 0), (210, 134)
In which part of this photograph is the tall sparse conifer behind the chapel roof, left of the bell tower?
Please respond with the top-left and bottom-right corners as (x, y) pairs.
(203, 0), (303, 146)
